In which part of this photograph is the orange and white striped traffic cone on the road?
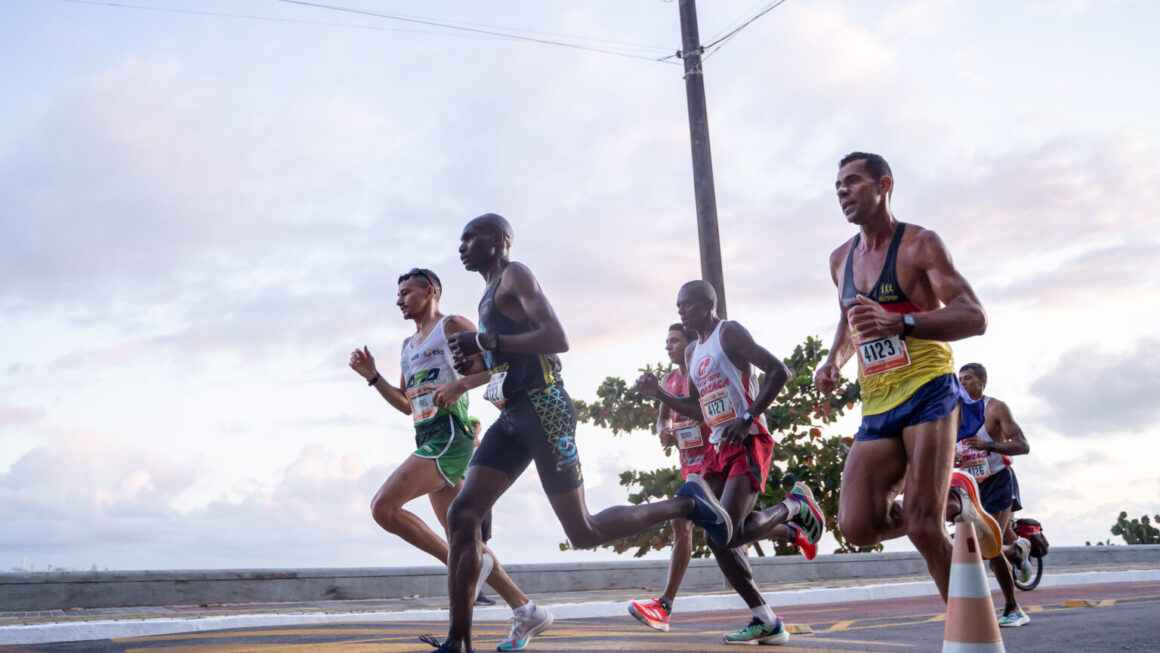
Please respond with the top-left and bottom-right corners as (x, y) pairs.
(943, 522), (1005, 653)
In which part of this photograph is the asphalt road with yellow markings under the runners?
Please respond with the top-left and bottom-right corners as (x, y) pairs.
(0, 582), (1160, 653)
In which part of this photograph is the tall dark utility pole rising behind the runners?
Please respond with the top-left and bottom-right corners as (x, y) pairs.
(681, 0), (726, 319)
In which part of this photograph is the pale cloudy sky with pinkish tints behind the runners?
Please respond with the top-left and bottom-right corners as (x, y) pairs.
(0, 0), (1160, 569)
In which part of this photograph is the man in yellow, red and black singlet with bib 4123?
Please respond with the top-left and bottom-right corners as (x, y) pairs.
(814, 152), (1002, 601)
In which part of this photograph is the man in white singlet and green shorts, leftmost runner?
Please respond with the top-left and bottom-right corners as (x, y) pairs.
(350, 268), (540, 649)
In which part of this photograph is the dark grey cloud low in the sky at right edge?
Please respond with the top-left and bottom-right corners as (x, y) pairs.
(1030, 339), (1160, 437)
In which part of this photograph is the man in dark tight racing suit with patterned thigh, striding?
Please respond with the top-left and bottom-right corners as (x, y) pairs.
(437, 213), (732, 653)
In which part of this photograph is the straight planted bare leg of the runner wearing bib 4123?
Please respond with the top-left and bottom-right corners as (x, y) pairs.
(902, 406), (959, 601)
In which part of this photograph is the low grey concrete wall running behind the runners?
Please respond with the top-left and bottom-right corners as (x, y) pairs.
(0, 545), (1160, 611)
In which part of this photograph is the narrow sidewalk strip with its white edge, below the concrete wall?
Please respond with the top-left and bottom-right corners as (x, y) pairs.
(0, 558), (1160, 645)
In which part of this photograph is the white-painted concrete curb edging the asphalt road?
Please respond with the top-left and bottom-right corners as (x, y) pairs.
(0, 569), (1160, 645)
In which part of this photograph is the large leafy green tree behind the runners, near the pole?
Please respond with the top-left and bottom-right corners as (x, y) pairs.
(560, 336), (882, 558)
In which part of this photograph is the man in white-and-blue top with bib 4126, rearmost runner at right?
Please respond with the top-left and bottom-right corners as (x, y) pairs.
(955, 363), (1031, 627)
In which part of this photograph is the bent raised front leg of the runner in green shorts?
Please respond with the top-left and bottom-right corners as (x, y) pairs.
(371, 456), (459, 564)
